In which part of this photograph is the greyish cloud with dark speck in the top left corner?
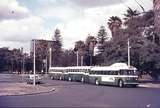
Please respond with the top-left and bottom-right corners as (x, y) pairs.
(0, 0), (29, 20)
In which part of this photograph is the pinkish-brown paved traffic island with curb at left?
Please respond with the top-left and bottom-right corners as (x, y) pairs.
(0, 83), (55, 96)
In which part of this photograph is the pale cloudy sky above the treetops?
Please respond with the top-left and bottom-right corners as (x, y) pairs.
(0, 0), (153, 52)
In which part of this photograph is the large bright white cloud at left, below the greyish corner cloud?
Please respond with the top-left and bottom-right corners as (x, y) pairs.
(0, 16), (43, 42)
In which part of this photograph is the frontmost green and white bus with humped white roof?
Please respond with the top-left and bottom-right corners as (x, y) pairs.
(89, 63), (138, 87)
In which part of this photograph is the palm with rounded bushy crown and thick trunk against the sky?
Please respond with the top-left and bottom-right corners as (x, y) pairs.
(108, 16), (122, 38)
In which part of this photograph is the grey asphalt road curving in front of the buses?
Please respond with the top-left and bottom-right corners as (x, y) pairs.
(0, 74), (160, 108)
